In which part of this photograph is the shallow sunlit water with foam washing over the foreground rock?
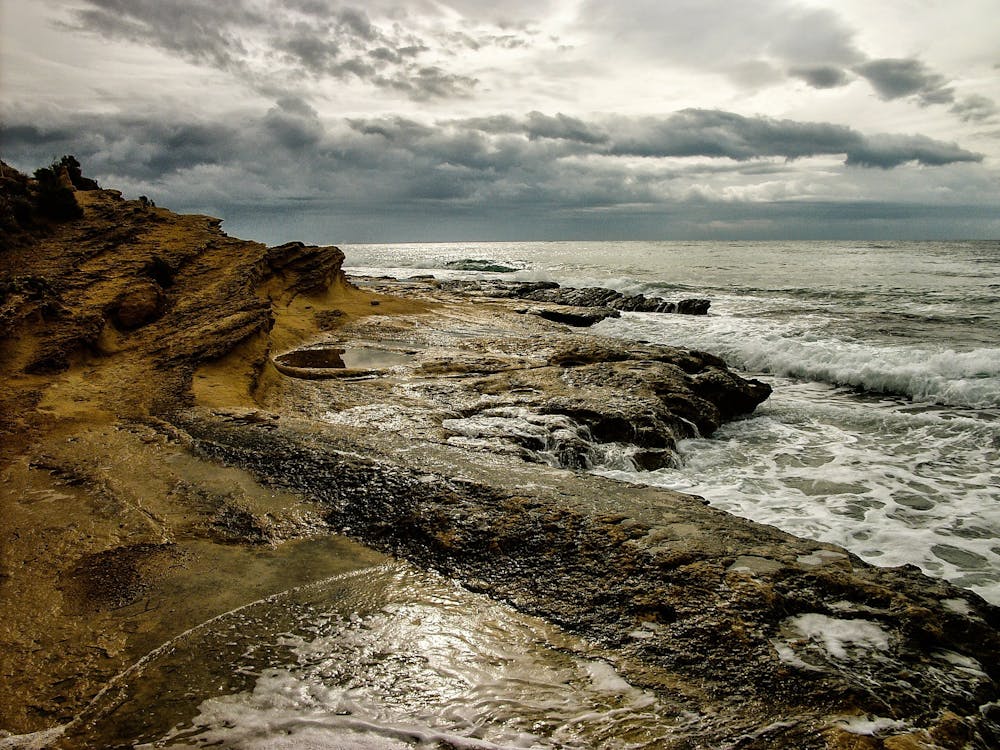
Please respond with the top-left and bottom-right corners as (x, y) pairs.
(62, 563), (679, 750)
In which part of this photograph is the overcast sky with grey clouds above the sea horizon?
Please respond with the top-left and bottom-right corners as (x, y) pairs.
(0, 0), (1000, 244)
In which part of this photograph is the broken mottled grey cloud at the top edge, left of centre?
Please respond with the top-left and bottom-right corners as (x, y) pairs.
(63, 0), (527, 101)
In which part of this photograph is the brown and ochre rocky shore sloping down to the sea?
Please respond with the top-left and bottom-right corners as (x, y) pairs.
(0, 166), (1000, 750)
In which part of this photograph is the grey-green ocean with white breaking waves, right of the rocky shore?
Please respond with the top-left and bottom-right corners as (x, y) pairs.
(342, 241), (1000, 604)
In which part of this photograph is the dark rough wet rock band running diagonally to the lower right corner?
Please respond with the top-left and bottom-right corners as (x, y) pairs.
(173, 412), (1000, 748)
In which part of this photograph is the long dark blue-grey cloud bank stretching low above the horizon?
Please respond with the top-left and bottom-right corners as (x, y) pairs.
(0, 103), (980, 241)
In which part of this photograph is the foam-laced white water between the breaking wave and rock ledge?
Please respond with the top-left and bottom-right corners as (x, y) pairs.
(601, 379), (1000, 603)
